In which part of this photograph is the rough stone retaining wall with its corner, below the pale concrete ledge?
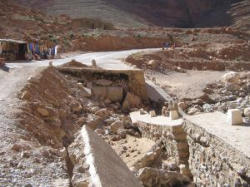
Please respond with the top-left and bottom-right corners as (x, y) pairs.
(135, 120), (250, 187)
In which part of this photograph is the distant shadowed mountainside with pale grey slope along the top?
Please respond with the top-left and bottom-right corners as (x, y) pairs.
(15, 0), (250, 28)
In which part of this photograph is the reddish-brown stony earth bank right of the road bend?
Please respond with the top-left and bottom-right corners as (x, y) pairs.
(127, 42), (250, 72)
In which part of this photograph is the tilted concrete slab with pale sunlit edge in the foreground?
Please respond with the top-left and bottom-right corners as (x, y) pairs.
(81, 126), (143, 187)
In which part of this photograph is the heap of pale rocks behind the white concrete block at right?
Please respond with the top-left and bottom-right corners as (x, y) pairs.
(182, 72), (250, 121)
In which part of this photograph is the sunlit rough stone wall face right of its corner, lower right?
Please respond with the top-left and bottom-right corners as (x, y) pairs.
(184, 121), (250, 186)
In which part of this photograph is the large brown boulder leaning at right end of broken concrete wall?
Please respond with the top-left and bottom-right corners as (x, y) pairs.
(122, 92), (141, 110)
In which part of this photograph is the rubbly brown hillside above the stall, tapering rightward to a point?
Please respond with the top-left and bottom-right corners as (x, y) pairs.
(0, 0), (114, 40)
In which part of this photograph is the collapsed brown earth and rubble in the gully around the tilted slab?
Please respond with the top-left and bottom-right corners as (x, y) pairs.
(2, 62), (196, 186)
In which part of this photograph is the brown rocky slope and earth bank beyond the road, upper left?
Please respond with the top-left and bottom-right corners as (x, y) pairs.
(0, 0), (170, 51)
